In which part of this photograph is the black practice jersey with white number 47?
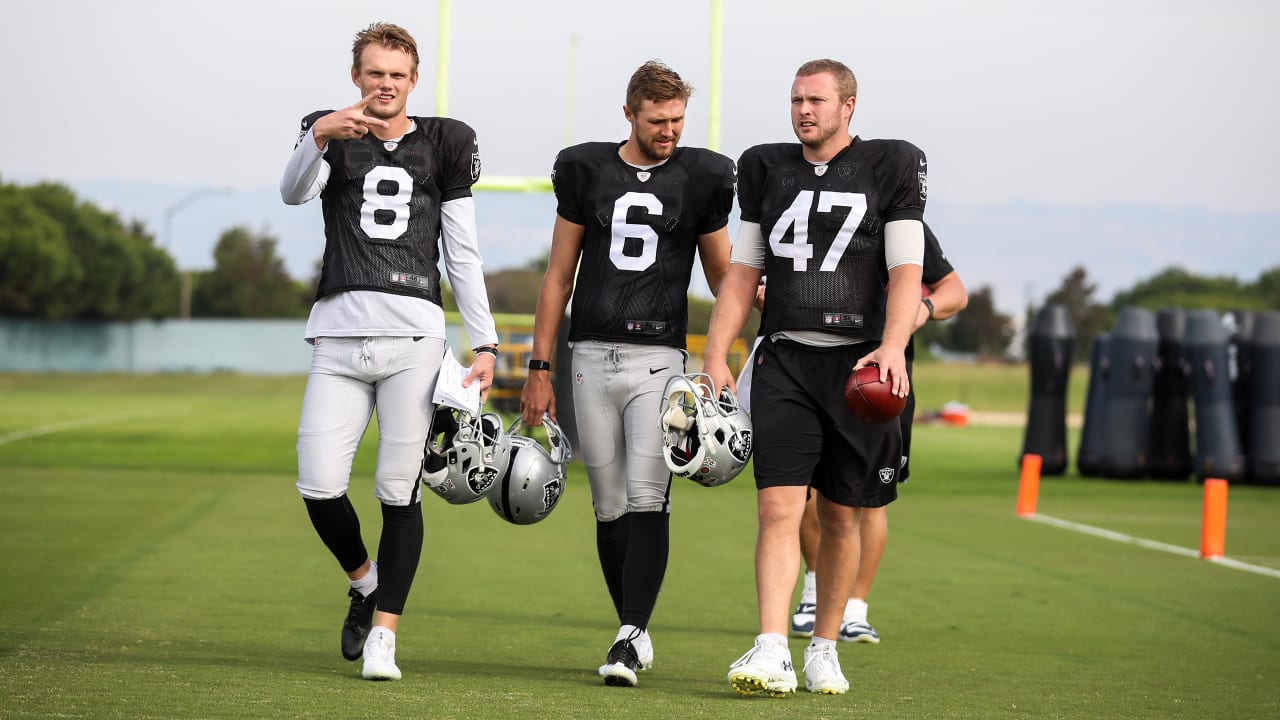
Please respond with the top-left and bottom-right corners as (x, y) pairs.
(739, 137), (927, 340)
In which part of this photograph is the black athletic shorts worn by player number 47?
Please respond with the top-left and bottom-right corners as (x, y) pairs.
(751, 340), (902, 507)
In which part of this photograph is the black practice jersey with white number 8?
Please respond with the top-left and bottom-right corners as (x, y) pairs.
(294, 110), (480, 305)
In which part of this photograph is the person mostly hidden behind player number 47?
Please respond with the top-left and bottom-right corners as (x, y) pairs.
(791, 223), (969, 643)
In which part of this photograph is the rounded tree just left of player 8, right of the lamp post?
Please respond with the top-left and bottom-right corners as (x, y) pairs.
(191, 227), (308, 318)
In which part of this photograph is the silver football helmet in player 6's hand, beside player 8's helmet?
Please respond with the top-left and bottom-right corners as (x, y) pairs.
(489, 414), (573, 525)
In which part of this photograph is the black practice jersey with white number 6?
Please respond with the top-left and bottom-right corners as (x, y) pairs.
(552, 142), (735, 348)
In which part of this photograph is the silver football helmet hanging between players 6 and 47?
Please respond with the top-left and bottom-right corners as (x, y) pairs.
(662, 373), (751, 488)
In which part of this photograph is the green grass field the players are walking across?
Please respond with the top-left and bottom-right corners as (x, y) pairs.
(0, 365), (1280, 720)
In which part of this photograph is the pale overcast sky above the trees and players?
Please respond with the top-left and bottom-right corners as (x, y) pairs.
(0, 0), (1280, 316)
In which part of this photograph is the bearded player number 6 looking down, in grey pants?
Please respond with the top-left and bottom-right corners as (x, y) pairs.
(521, 61), (735, 687)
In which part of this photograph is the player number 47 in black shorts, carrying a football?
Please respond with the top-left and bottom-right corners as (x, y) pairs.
(705, 60), (927, 696)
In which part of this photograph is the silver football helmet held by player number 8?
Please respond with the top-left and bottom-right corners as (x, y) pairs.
(421, 405), (511, 505)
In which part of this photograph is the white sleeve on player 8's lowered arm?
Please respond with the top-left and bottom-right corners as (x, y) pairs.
(440, 197), (498, 347)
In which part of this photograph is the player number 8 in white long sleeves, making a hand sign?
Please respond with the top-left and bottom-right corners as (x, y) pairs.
(280, 23), (498, 680)
